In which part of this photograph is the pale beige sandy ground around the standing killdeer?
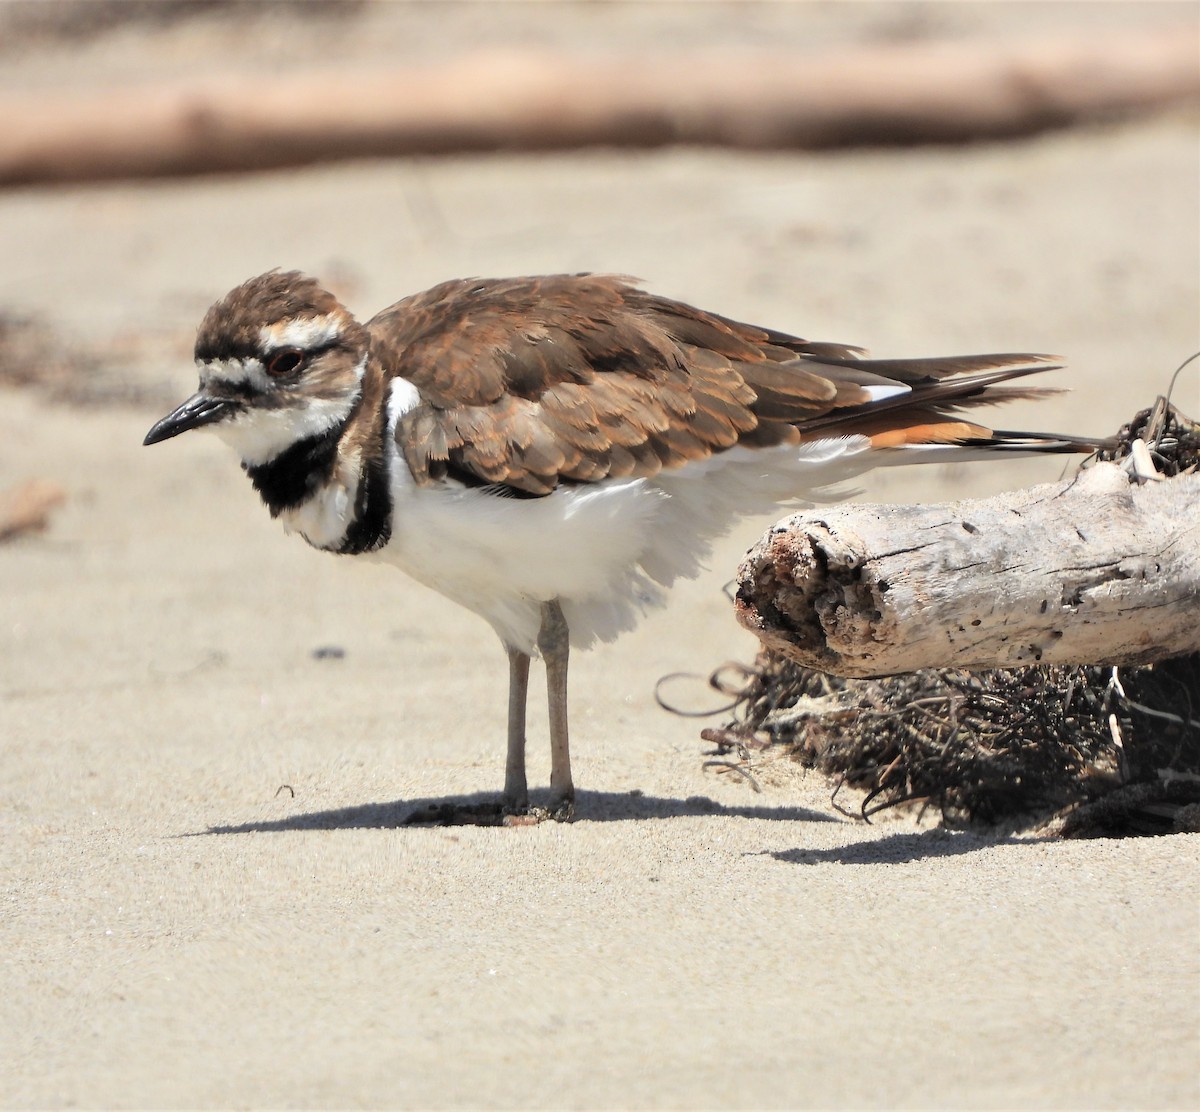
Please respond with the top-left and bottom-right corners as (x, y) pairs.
(0, 5), (1200, 1108)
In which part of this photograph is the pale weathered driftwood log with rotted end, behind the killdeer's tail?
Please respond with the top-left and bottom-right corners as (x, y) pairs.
(737, 463), (1200, 677)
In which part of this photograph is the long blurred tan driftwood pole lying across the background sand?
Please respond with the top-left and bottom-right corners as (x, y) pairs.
(0, 25), (1200, 185)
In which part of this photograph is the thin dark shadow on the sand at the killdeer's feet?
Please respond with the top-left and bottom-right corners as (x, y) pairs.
(192, 792), (842, 837)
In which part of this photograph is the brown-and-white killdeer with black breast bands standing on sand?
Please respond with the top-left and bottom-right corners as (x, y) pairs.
(145, 271), (1090, 818)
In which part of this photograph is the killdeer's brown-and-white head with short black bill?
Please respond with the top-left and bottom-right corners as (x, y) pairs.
(144, 271), (368, 465)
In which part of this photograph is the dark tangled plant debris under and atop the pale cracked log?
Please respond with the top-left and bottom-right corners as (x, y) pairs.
(702, 398), (1200, 837)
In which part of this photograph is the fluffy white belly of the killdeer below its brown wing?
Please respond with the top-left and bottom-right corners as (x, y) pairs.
(364, 384), (878, 651)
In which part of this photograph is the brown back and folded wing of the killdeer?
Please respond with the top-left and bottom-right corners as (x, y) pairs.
(367, 275), (1060, 495)
